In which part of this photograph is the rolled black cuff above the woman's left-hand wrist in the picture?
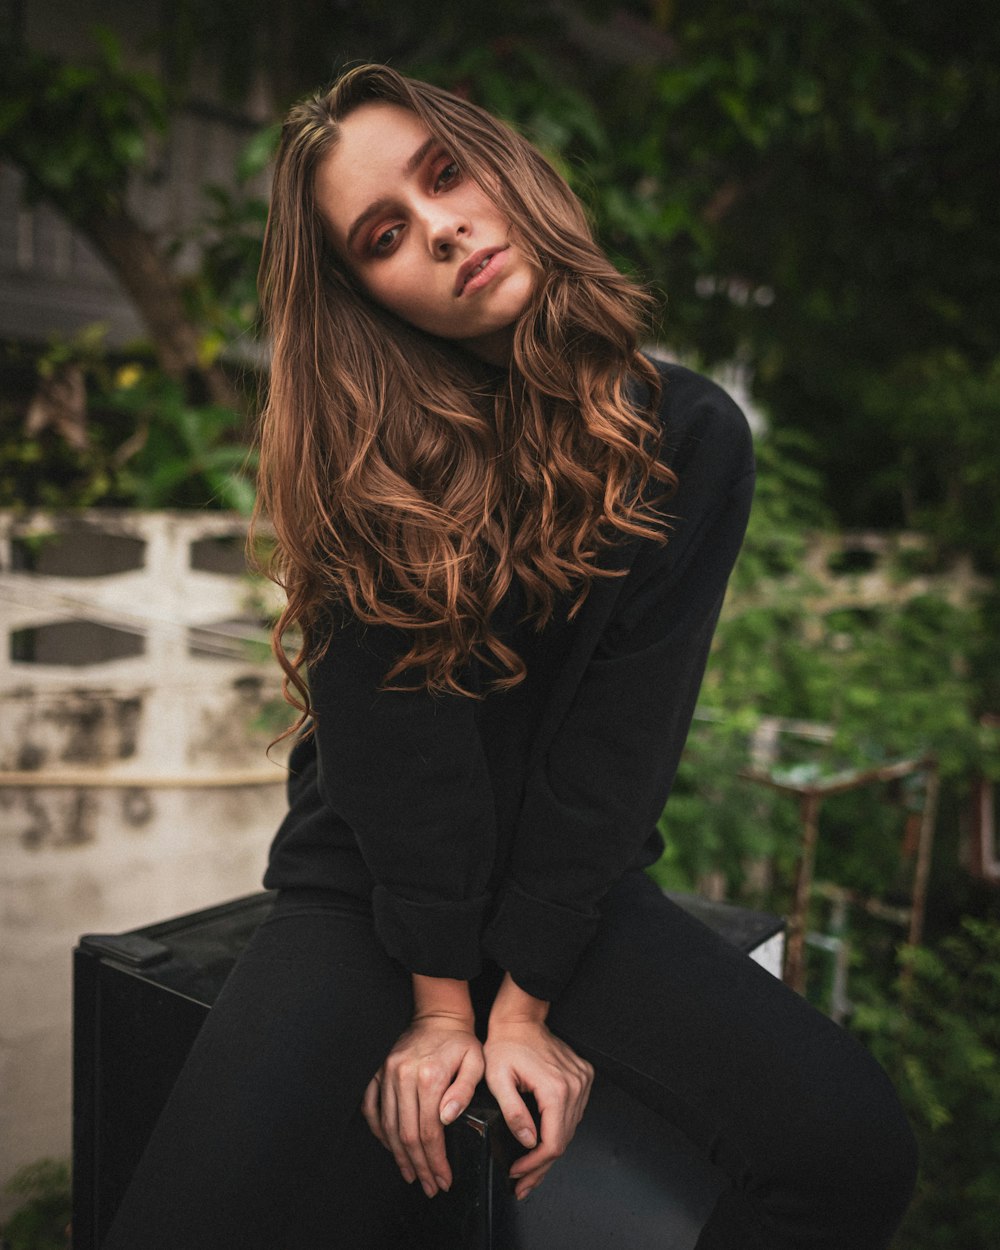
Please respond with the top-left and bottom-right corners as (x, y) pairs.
(371, 885), (490, 981)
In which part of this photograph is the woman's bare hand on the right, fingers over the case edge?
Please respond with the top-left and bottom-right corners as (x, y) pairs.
(484, 1015), (594, 1199)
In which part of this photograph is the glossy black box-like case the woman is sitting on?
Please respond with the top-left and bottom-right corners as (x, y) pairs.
(73, 894), (783, 1250)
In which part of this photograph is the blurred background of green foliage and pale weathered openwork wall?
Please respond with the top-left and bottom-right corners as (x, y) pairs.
(0, 0), (1000, 1250)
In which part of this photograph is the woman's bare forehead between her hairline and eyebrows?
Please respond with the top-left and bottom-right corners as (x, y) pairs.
(316, 100), (429, 245)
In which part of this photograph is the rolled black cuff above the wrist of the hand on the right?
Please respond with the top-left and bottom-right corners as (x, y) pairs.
(483, 881), (600, 1003)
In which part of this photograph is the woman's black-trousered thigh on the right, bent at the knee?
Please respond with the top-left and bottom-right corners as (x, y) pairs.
(550, 873), (913, 1250)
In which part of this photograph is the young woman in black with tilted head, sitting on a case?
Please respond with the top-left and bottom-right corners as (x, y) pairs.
(108, 66), (915, 1250)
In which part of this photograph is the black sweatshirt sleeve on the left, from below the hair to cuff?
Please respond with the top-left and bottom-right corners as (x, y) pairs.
(309, 618), (496, 980)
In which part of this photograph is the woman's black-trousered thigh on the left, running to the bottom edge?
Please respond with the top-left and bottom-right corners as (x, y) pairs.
(105, 900), (422, 1250)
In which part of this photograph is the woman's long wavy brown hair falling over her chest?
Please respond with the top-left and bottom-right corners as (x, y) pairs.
(251, 65), (674, 733)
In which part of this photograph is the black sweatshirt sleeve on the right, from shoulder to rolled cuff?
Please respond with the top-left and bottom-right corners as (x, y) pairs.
(484, 393), (754, 1000)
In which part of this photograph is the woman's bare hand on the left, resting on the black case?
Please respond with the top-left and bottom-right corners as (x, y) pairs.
(361, 1013), (485, 1198)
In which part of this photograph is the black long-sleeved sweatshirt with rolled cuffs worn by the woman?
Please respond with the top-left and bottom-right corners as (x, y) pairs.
(264, 365), (754, 1000)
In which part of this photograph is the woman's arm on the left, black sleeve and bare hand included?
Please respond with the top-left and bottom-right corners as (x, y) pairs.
(309, 619), (496, 1196)
